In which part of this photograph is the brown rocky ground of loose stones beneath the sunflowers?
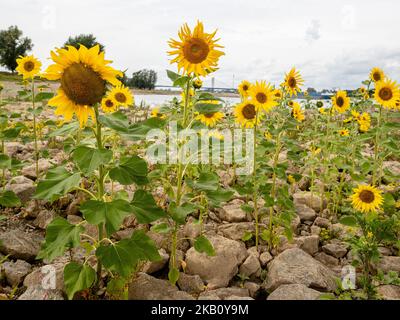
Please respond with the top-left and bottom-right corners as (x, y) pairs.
(0, 96), (400, 300)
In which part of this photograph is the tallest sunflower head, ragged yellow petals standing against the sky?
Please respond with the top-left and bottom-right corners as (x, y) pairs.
(168, 21), (224, 76)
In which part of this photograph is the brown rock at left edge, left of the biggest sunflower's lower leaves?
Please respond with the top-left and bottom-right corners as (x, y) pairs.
(0, 229), (44, 261)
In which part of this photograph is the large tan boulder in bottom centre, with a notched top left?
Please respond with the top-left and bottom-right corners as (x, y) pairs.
(185, 236), (248, 289)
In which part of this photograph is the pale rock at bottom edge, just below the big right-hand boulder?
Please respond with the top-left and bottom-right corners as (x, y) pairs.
(267, 284), (321, 300)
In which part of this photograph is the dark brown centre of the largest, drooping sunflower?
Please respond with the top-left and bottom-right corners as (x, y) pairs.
(61, 63), (106, 106)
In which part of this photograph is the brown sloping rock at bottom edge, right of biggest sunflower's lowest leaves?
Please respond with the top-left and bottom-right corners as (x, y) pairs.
(128, 272), (194, 300)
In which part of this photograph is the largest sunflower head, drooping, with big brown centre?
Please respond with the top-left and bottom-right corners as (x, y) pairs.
(45, 45), (122, 126)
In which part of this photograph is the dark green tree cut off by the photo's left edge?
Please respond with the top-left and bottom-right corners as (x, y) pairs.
(0, 26), (33, 73)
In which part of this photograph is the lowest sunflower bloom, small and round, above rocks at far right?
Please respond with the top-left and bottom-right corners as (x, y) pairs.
(351, 185), (383, 213)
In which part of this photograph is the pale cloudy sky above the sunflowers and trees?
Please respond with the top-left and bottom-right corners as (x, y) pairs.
(0, 0), (400, 89)
